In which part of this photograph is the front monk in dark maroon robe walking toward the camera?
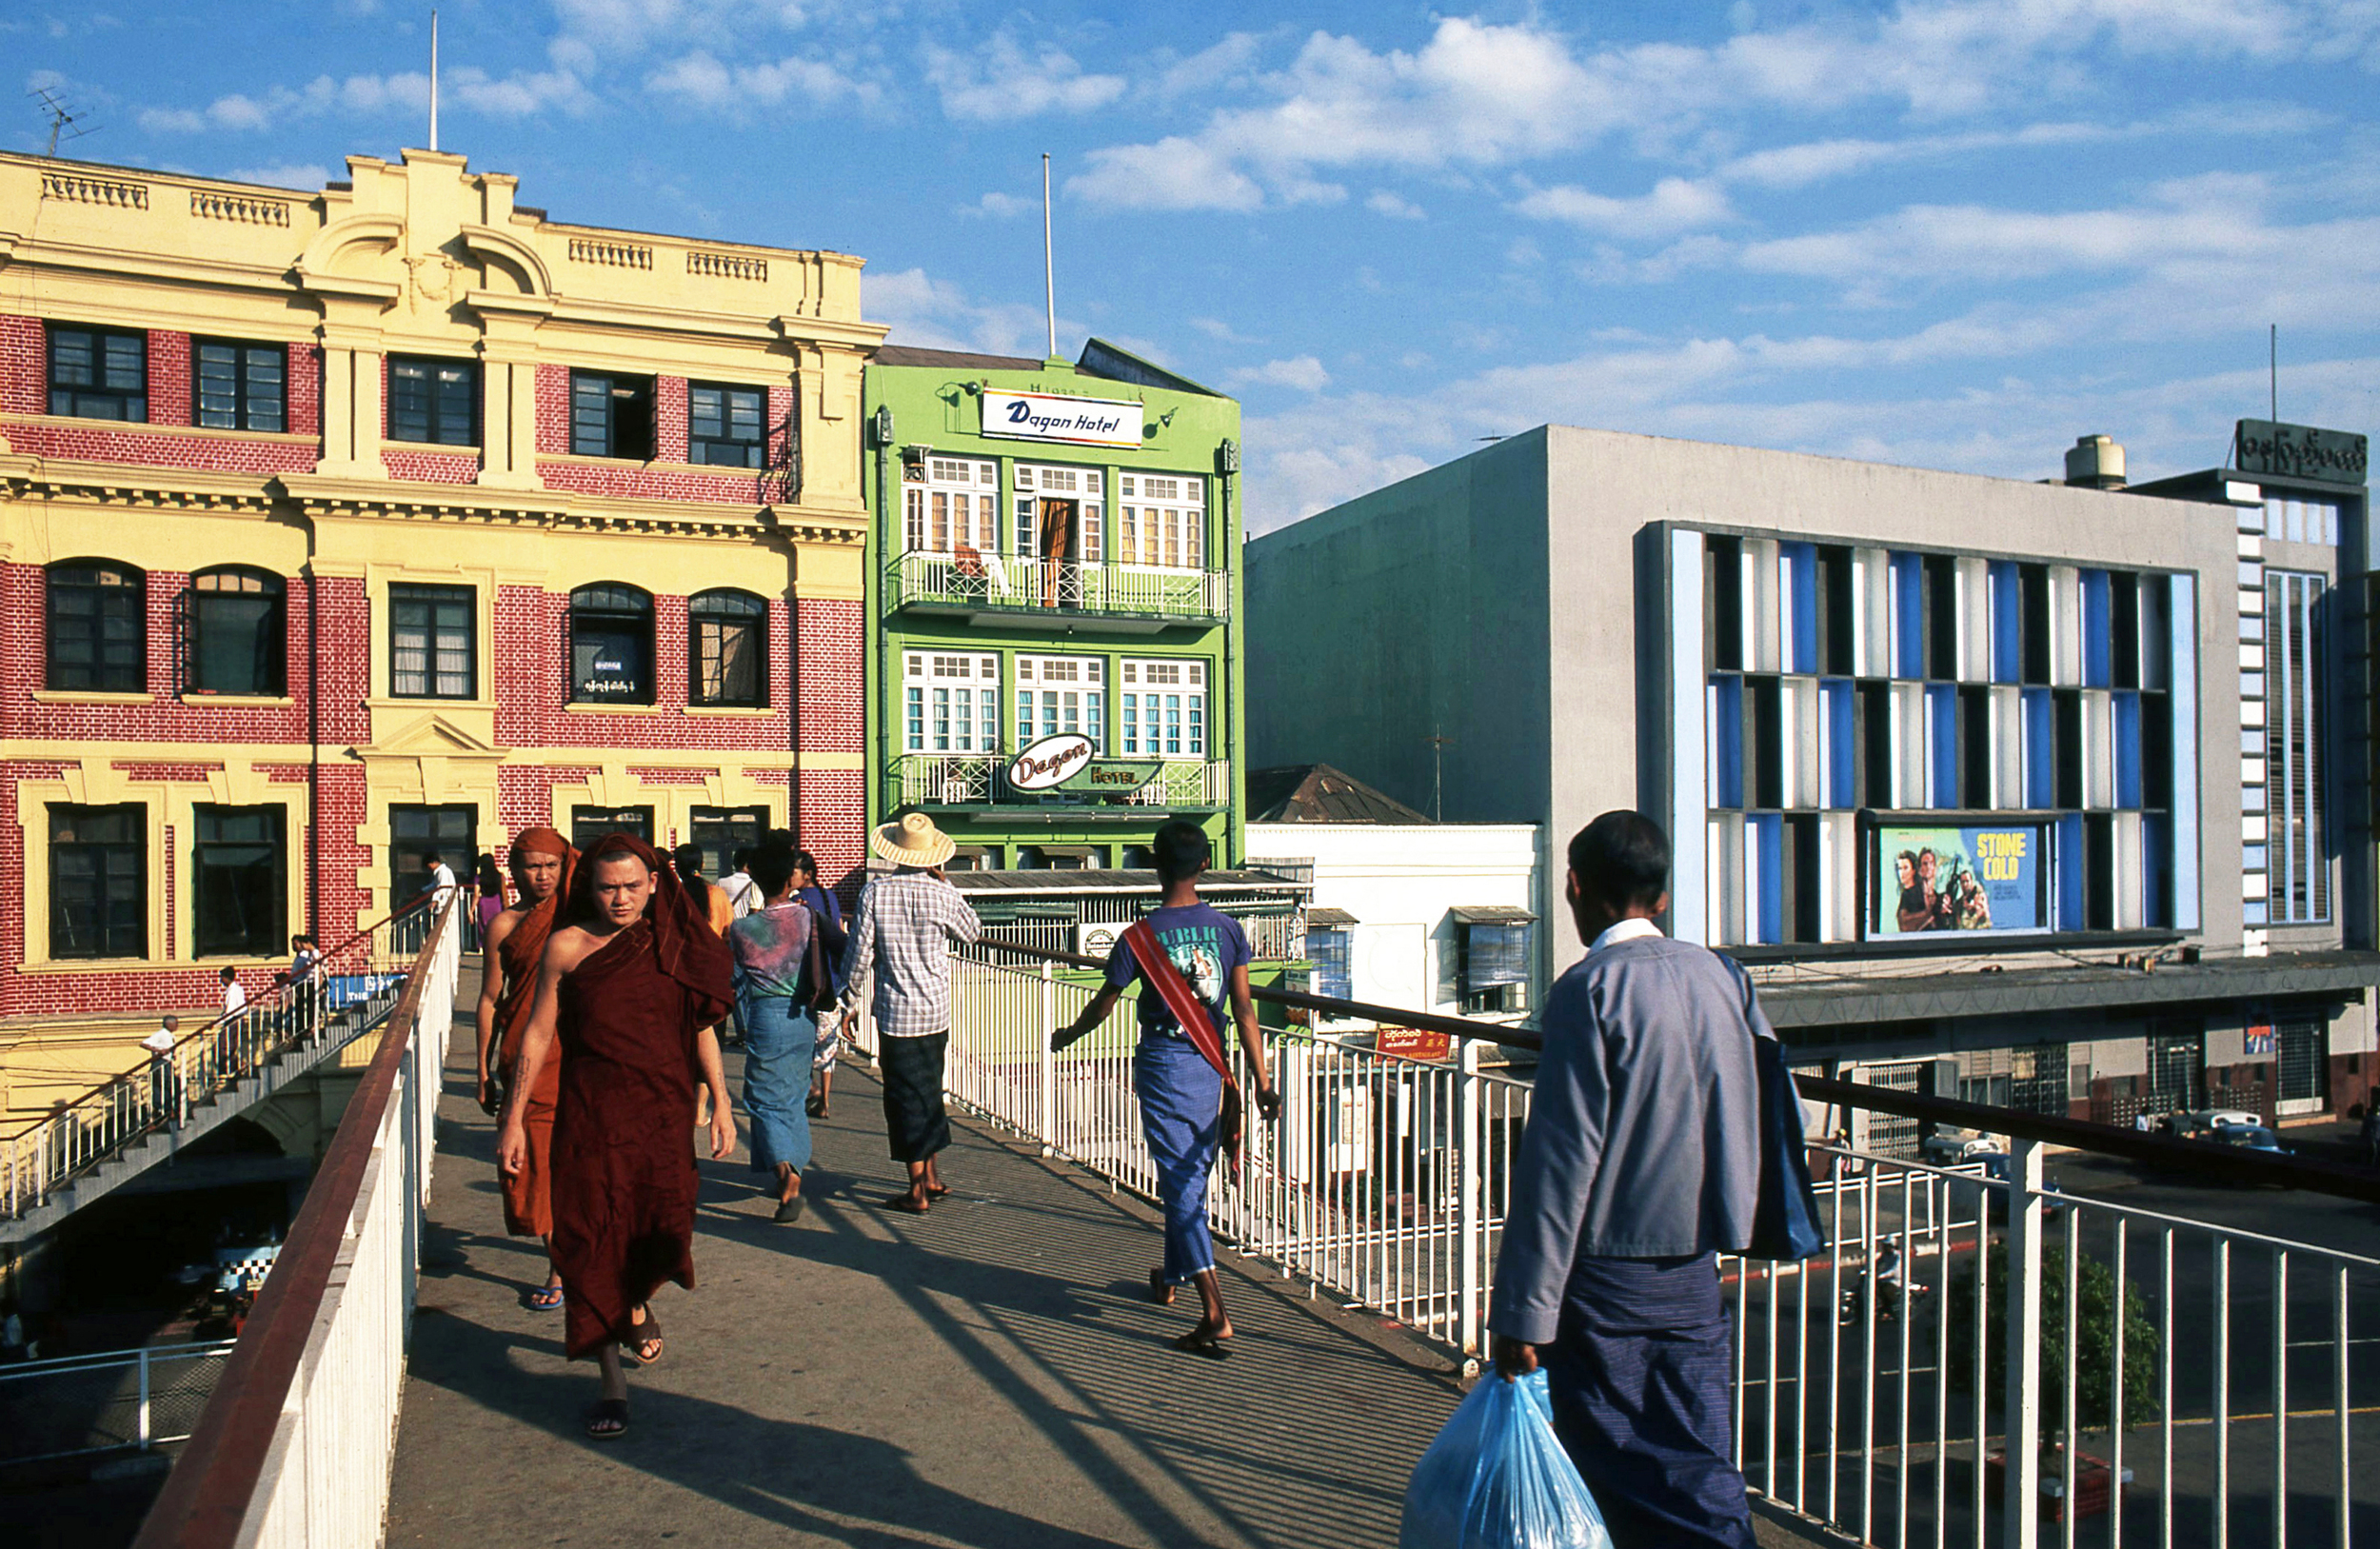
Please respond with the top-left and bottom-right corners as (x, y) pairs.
(498, 833), (736, 1440)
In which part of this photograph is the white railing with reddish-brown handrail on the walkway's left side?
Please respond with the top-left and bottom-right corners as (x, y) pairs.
(136, 897), (462, 1549)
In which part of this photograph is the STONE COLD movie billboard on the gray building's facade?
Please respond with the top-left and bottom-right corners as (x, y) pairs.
(1869, 821), (2050, 940)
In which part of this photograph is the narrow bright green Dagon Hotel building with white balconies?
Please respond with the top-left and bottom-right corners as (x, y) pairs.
(864, 340), (1299, 962)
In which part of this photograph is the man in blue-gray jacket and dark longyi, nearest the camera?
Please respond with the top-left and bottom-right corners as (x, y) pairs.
(1488, 811), (1774, 1549)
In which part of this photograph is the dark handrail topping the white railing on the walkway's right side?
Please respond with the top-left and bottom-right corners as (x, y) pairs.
(976, 938), (2380, 1204)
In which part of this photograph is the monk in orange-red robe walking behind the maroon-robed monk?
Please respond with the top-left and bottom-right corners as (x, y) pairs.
(479, 828), (579, 1314)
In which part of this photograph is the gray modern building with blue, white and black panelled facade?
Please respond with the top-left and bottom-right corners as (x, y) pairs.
(1247, 426), (2380, 1144)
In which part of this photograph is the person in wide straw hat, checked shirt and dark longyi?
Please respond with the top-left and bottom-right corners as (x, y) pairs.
(843, 811), (983, 1216)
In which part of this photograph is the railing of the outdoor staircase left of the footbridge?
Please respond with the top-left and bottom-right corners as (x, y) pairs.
(0, 900), (457, 1221)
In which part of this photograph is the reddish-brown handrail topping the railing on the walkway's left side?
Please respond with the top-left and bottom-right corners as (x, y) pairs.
(133, 890), (460, 1549)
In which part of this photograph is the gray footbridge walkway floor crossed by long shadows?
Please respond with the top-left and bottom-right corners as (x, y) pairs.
(388, 1018), (1459, 1549)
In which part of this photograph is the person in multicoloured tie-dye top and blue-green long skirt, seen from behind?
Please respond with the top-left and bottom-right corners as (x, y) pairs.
(728, 847), (823, 1221)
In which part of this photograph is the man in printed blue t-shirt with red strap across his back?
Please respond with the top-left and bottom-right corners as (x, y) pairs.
(1050, 819), (1280, 1359)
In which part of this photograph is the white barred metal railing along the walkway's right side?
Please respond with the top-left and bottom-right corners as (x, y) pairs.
(860, 943), (2380, 1549)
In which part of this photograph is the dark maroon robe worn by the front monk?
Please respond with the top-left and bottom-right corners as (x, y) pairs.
(552, 835), (731, 1357)
